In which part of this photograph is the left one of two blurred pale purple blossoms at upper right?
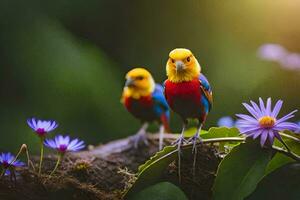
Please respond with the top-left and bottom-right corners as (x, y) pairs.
(258, 44), (288, 61)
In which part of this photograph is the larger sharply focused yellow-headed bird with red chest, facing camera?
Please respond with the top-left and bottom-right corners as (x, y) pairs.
(164, 48), (212, 153)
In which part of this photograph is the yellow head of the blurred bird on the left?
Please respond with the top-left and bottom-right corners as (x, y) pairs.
(123, 68), (155, 99)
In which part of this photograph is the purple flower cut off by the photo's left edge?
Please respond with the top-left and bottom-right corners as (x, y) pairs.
(0, 152), (25, 175)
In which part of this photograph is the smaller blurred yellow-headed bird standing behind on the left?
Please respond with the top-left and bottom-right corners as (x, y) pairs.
(121, 68), (170, 149)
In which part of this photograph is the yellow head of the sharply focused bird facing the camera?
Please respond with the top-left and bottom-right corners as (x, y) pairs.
(166, 48), (201, 83)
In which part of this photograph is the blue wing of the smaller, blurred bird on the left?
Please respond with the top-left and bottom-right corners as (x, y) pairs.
(152, 84), (170, 118)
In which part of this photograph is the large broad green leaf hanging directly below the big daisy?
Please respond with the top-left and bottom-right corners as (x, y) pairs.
(213, 141), (272, 200)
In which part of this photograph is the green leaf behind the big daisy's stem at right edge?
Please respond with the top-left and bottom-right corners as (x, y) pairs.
(266, 137), (300, 174)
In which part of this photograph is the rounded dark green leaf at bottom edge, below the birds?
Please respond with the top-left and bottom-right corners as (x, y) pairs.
(129, 182), (188, 200)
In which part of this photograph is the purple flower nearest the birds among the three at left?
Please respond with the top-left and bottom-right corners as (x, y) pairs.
(44, 135), (85, 153)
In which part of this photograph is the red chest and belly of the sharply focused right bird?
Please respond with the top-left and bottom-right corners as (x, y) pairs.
(165, 79), (202, 117)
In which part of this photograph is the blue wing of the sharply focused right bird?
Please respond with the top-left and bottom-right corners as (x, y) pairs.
(199, 73), (213, 112)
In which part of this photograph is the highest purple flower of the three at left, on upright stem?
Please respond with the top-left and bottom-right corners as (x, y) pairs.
(27, 118), (58, 137)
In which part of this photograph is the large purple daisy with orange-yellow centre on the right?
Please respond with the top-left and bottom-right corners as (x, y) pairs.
(236, 98), (299, 146)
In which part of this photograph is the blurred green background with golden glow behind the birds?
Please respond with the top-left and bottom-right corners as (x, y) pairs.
(0, 0), (300, 152)
